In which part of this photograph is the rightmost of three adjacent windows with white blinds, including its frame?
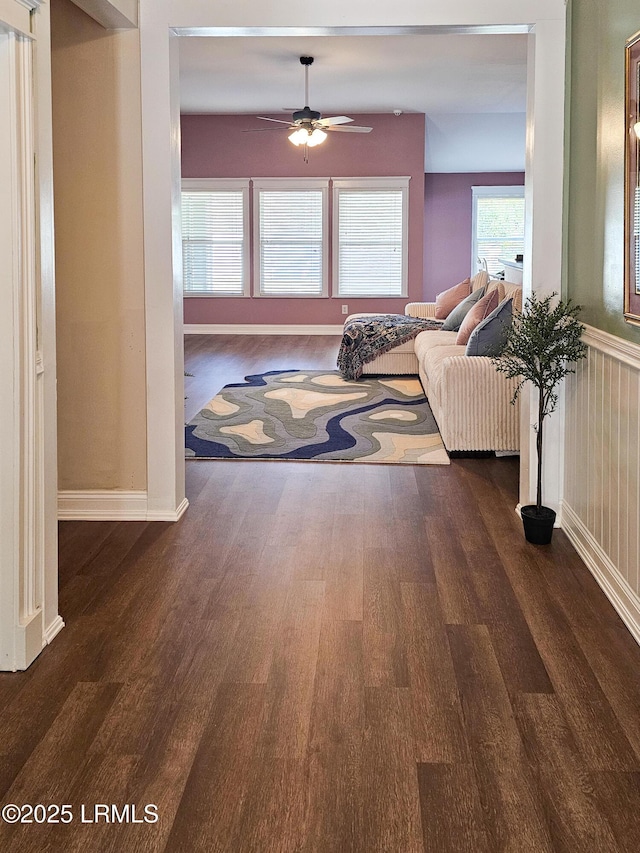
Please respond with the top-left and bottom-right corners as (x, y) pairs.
(333, 178), (409, 297)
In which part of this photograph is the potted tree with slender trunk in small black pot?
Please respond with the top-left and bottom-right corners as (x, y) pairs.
(492, 293), (587, 545)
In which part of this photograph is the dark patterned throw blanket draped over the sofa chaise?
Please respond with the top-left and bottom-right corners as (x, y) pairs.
(338, 314), (442, 379)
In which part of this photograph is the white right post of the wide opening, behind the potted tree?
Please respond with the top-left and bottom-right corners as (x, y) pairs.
(520, 18), (566, 525)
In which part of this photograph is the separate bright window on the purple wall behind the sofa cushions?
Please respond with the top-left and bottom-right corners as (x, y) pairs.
(471, 186), (524, 275)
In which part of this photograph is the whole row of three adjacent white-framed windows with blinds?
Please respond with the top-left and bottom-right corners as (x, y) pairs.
(182, 177), (409, 298)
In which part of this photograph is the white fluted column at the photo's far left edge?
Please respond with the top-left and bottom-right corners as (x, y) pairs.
(0, 0), (63, 670)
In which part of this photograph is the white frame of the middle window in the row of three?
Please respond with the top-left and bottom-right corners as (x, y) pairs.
(251, 177), (330, 299)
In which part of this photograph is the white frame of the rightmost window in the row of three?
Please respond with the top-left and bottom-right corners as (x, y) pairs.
(331, 175), (411, 299)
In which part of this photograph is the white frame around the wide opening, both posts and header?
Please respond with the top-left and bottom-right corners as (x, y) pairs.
(140, 0), (566, 518)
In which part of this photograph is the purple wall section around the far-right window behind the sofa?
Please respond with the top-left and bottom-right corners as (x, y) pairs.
(424, 172), (524, 302)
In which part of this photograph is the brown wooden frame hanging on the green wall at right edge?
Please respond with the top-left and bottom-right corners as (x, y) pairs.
(624, 32), (640, 325)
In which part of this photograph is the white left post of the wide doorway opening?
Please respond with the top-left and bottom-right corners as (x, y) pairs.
(140, 0), (188, 521)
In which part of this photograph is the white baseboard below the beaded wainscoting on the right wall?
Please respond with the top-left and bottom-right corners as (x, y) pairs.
(562, 503), (640, 645)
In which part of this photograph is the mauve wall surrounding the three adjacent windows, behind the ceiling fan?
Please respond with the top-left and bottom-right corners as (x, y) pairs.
(181, 113), (425, 325)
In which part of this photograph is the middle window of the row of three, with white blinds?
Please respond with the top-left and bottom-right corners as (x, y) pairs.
(253, 178), (329, 297)
